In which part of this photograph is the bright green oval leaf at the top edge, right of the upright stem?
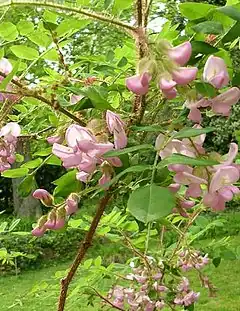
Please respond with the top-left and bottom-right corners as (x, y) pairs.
(179, 2), (216, 20)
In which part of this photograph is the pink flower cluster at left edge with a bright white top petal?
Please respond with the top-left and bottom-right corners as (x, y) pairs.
(0, 122), (21, 172)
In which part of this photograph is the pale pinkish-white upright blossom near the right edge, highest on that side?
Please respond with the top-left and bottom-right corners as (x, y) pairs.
(203, 55), (229, 89)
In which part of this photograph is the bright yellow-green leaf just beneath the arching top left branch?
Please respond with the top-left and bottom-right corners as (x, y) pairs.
(56, 18), (90, 37)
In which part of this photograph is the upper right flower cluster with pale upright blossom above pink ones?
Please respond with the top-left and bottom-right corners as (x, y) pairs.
(185, 55), (240, 123)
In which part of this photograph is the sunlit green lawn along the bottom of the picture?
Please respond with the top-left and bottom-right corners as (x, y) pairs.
(0, 236), (240, 311)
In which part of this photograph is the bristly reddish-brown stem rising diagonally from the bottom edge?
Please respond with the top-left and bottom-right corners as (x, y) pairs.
(58, 191), (111, 311)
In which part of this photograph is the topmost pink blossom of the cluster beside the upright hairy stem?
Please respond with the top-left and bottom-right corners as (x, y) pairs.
(168, 41), (192, 66)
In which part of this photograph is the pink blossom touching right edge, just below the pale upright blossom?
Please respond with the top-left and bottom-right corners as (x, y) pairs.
(211, 87), (240, 116)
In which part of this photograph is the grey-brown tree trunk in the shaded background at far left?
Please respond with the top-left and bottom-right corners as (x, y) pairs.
(12, 138), (42, 218)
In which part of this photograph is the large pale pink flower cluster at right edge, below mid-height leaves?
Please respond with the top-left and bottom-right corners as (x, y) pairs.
(157, 125), (240, 214)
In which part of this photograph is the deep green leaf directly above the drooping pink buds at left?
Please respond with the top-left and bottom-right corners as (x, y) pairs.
(52, 170), (82, 197)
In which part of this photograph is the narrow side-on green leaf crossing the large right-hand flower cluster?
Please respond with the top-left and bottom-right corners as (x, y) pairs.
(158, 153), (219, 169)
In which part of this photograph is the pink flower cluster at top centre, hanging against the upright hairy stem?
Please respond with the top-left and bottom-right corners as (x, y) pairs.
(126, 41), (198, 99)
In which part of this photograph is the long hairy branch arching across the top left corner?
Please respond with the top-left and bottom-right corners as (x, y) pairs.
(0, 0), (136, 32)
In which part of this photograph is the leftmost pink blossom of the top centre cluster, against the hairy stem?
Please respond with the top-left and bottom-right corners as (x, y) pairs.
(126, 72), (152, 95)
